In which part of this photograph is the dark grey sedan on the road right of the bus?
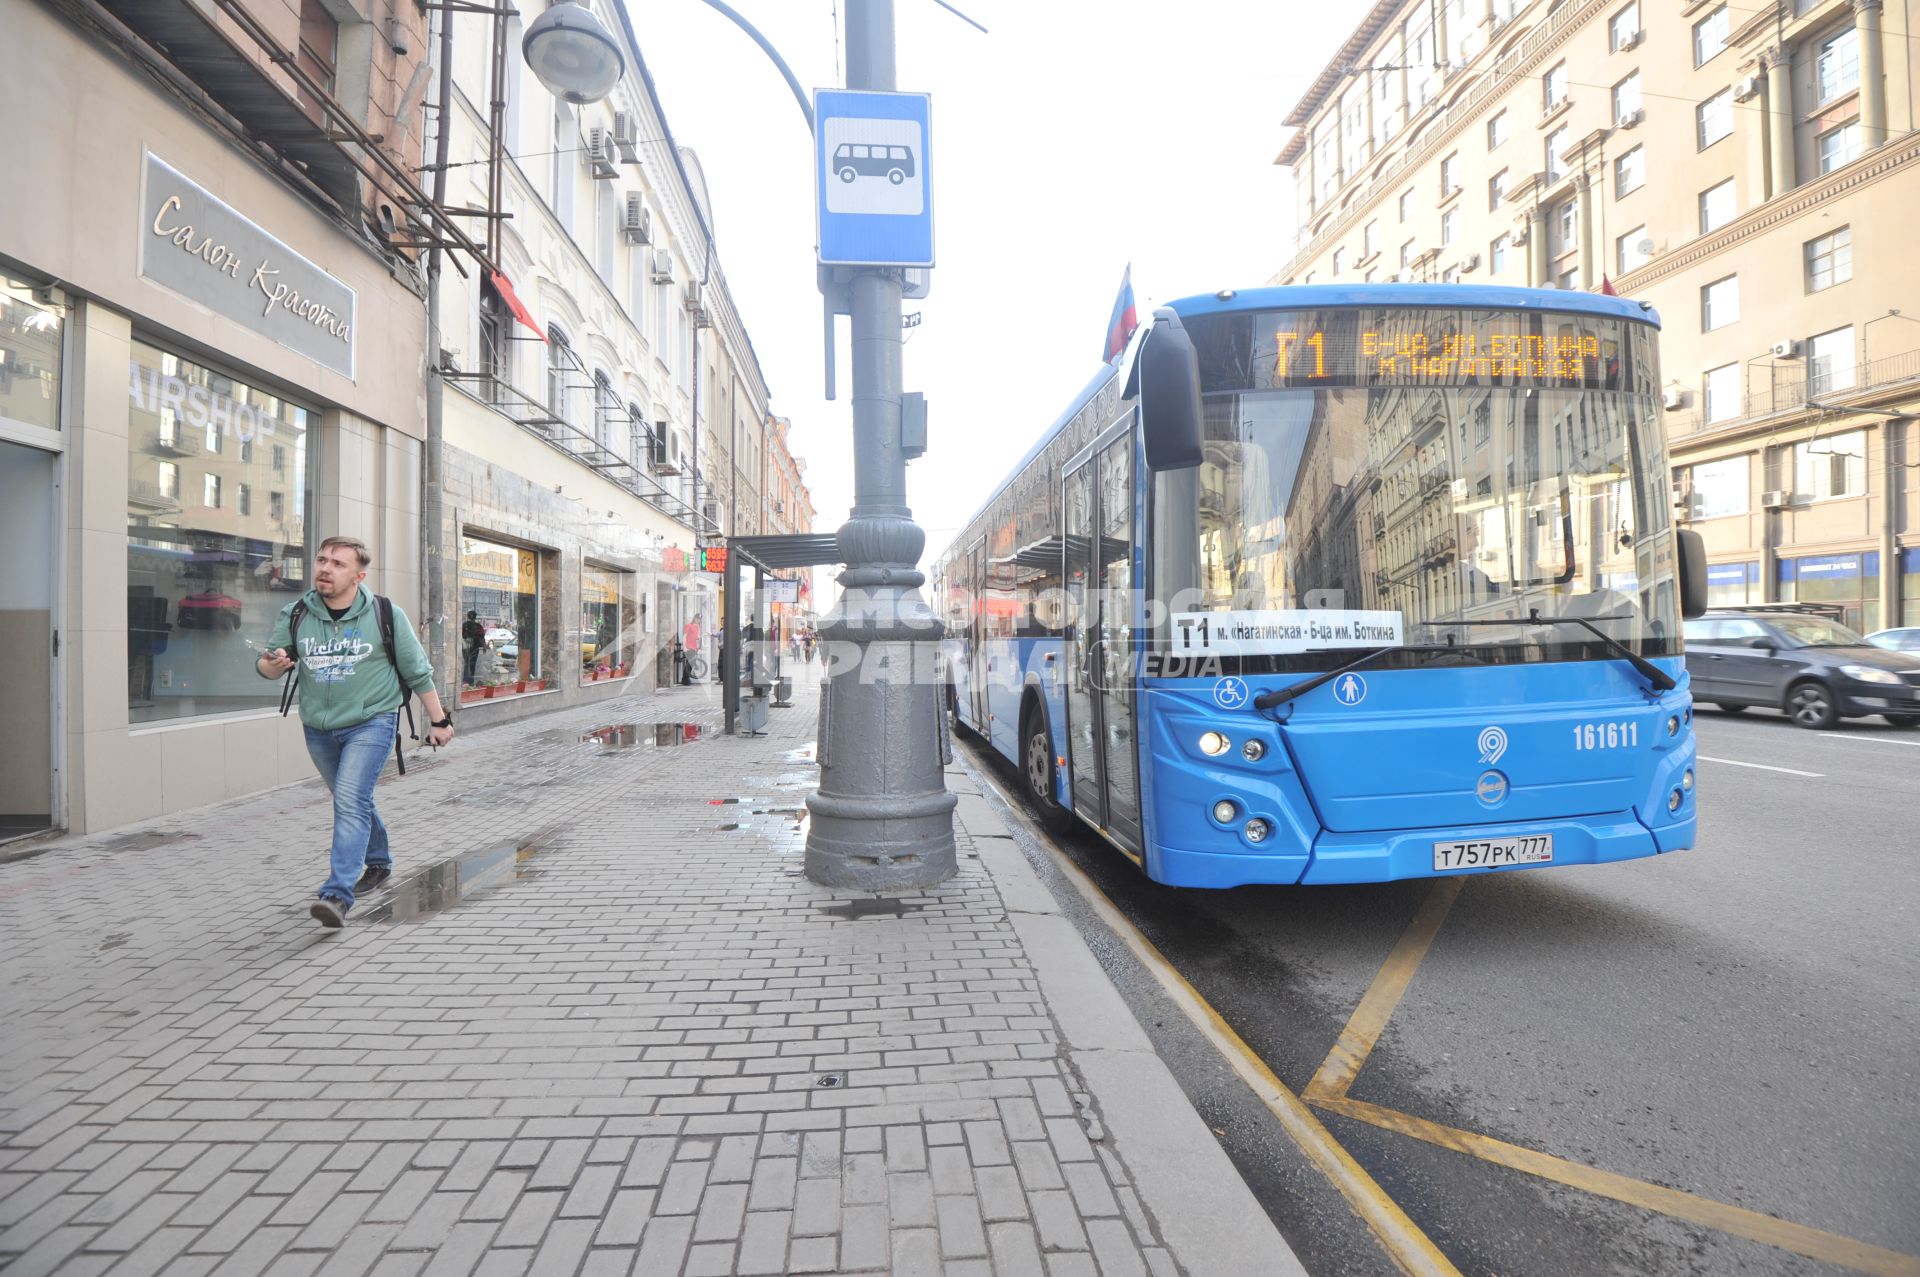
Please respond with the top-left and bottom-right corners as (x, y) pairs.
(1686, 605), (1920, 728)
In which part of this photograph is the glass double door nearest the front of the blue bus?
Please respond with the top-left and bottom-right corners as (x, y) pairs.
(1066, 432), (1140, 855)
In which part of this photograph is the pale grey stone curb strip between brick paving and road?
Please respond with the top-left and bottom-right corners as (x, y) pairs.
(948, 768), (1306, 1277)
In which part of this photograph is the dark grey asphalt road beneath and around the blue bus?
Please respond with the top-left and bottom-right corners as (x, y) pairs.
(960, 709), (1920, 1275)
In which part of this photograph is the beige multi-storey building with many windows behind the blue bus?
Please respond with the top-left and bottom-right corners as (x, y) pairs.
(1273, 0), (1920, 630)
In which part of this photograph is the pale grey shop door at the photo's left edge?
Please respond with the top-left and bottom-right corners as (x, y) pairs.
(0, 442), (60, 841)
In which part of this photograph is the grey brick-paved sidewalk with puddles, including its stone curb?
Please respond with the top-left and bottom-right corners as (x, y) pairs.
(0, 672), (1298, 1277)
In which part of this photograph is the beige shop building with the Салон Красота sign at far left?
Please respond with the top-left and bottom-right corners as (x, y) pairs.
(0, 0), (424, 835)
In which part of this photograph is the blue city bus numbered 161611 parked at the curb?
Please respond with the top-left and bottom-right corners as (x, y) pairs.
(931, 284), (1707, 887)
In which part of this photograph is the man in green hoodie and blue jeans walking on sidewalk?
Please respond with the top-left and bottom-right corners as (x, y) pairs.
(253, 536), (453, 928)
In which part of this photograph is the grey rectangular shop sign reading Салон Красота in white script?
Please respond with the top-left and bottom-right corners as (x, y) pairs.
(140, 154), (355, 378)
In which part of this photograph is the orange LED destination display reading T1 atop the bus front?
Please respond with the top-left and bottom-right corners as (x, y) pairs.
(1188, 307), (1630, 390)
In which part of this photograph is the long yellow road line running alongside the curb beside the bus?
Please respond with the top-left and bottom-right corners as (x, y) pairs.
(979, 774), (1459, 1277)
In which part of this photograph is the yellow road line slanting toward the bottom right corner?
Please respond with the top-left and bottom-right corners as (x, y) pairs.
(1313, 1096), (1920, 1277)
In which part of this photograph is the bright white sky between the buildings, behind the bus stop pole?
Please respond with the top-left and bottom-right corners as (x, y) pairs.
(626, 0), (1367, 565)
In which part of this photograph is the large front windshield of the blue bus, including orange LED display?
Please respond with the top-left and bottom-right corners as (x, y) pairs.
(1152, 307), (1680, 672)
